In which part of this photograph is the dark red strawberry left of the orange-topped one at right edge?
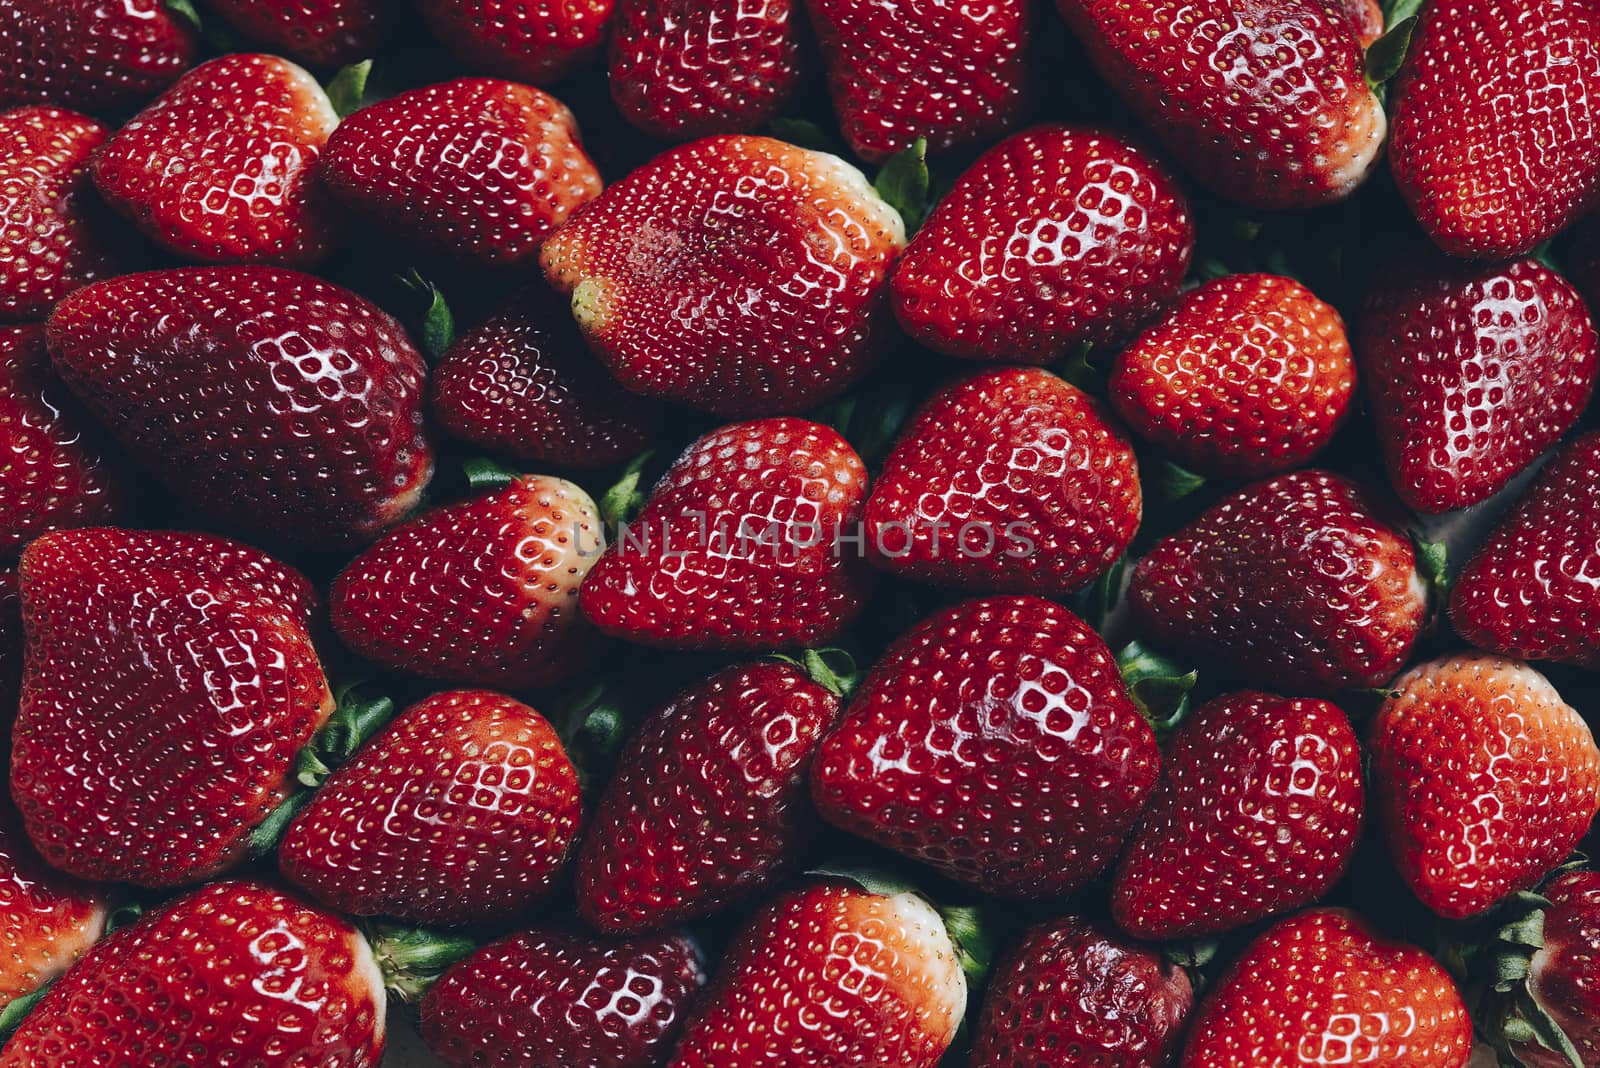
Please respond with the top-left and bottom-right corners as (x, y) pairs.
(1112, 692), (1363, 942)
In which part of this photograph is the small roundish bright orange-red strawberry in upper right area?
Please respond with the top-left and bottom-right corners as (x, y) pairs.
(1110, 275), (1355, 478)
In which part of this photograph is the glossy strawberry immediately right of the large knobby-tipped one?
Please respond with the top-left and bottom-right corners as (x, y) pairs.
(891, 126), (1195, 363)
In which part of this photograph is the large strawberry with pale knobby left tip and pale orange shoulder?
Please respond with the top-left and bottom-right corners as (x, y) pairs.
(541, 137), (906, 416)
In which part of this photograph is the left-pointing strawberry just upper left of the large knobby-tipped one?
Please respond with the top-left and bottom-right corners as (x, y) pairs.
(318, 78), (600, 267)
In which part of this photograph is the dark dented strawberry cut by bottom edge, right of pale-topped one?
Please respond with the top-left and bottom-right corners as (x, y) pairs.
(971, 916), (1194, 1068)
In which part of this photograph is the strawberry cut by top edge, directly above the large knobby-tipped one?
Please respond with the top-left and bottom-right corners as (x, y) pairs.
(610, 0), (800, 139)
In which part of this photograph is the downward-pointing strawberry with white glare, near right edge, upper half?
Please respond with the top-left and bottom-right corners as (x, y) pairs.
(1357, 257), (1600, 512)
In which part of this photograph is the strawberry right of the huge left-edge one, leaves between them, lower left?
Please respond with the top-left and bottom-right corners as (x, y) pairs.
(278, 691), (582, 924)
